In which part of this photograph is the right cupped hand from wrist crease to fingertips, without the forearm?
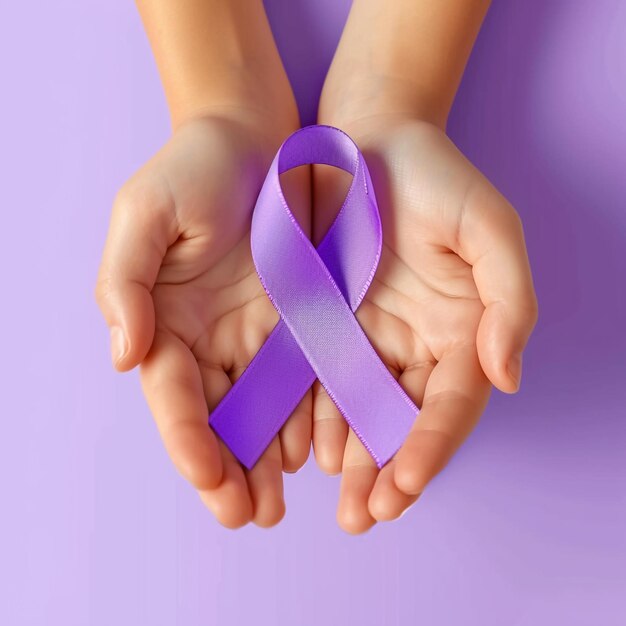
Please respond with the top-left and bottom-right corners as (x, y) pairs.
(313, 113), (537, 533)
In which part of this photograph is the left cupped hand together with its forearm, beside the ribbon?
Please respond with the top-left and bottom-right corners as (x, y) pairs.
(96, 0), (312, 528)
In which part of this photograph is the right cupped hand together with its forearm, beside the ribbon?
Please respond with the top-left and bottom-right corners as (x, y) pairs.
(313, 0), (537, 534)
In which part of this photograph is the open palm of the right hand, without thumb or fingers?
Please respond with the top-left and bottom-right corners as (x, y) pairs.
(360, 122), (484, 372)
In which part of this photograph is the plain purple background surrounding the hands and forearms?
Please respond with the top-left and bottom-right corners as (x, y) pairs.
(0, 0), (626, 626)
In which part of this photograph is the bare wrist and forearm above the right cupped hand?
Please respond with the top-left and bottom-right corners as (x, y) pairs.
(319, 0), (489, 129)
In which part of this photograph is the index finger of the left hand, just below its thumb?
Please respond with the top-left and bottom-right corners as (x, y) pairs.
(141, 331), (222, 489)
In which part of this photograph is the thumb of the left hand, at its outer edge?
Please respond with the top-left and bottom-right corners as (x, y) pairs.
(96, 178), (176, 371)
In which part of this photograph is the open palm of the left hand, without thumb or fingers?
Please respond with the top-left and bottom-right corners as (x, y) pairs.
(152, 120), (277, 409)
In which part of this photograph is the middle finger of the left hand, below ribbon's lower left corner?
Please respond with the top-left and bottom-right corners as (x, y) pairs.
(200, 442), (254, 528)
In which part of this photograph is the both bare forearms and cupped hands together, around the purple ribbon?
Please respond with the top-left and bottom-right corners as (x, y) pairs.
(96, 0), (537, 533)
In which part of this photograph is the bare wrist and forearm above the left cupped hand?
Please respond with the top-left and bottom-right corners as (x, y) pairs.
(137, 0), (297, 134)
